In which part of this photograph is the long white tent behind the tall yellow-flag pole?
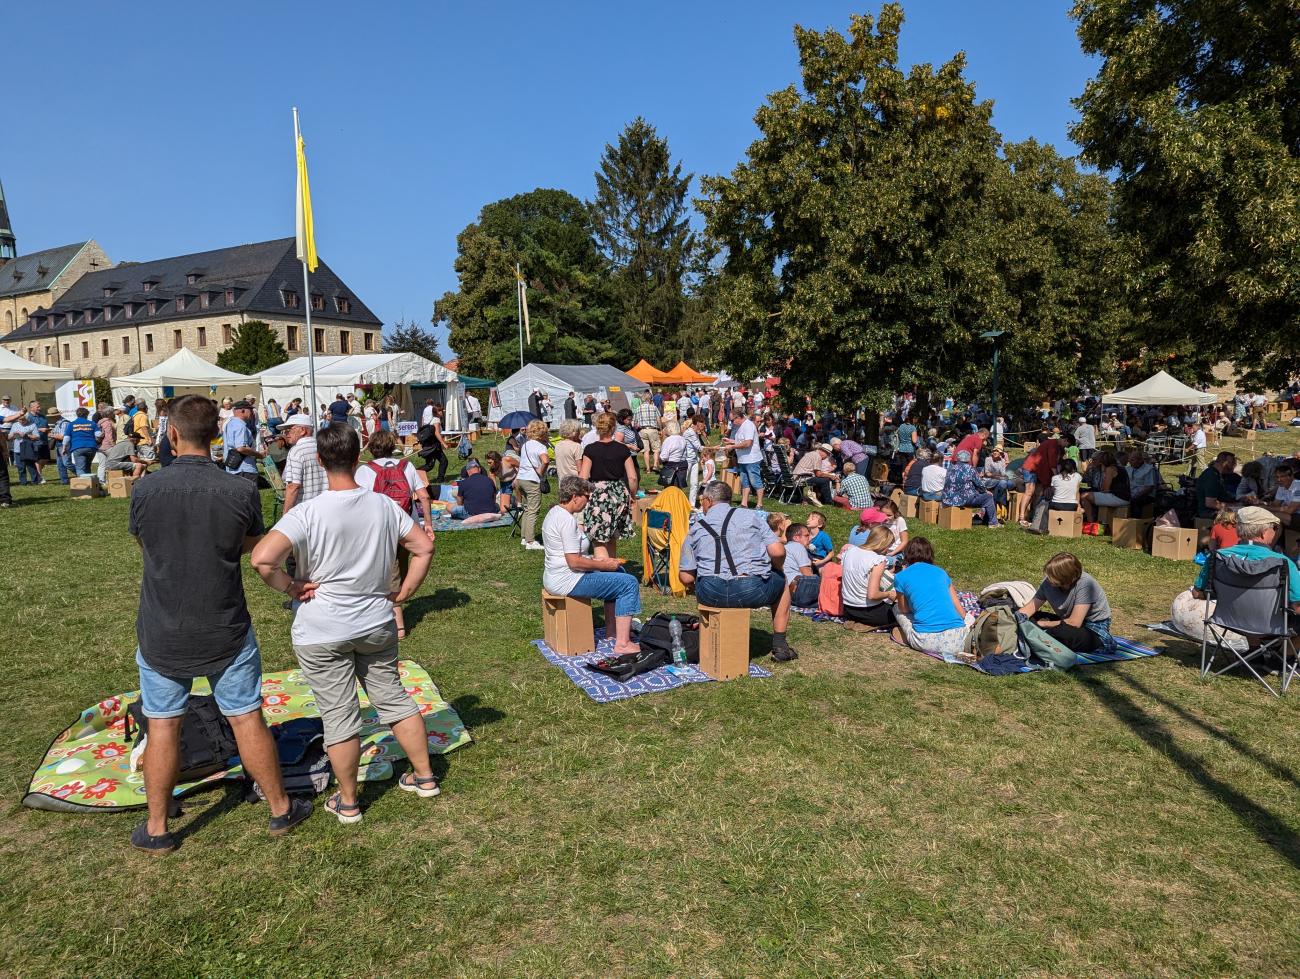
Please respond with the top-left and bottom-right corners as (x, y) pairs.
(259, 354), (464, 432)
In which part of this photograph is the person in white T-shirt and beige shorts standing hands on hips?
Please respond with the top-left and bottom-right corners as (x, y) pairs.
(250, 423), (438, 824)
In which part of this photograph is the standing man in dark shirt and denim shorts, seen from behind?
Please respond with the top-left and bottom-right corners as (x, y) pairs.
(129, 395), (315, 854)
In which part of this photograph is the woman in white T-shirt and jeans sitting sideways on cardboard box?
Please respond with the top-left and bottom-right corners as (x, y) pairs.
(542, 476), (641, 655)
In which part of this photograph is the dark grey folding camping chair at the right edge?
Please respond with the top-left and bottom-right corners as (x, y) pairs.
(1201, 551), (1297, 697)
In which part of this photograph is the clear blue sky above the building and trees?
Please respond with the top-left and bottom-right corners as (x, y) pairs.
(0, 0), (1095, 356)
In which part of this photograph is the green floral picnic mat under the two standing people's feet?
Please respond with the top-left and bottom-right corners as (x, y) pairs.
(22, 659), (471, 813)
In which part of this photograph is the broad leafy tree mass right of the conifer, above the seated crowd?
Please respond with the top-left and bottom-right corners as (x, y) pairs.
(697, 4), (1119, 407)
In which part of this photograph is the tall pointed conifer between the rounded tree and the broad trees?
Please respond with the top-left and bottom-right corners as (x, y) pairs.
(592, 116), (694, 368)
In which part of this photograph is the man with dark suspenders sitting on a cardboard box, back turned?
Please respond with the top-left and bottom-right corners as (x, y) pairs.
(680, 482), (798, 662)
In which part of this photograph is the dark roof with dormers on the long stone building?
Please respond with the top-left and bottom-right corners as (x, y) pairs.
(0, 238), (382, 343)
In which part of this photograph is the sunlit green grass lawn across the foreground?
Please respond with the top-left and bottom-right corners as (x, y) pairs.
(0, 433), (1300, 976)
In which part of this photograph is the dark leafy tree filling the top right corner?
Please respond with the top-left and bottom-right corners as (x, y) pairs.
(1071, 0), (1300, 384)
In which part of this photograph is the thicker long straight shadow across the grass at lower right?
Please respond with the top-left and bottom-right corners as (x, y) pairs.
(1079, 675), (1300, 870)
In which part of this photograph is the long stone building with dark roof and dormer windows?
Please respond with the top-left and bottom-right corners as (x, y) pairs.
(0, 238), (384, 377)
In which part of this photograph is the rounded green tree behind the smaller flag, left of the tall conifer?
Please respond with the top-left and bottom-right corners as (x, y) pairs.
(433, 190), (618, 377)
